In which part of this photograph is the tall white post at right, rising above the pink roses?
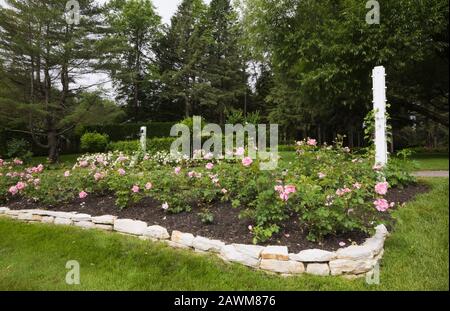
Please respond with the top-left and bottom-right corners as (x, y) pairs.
(372, 66), (388, 166)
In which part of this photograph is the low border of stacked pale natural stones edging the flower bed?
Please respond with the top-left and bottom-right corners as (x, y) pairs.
(0, 207), (389, 277)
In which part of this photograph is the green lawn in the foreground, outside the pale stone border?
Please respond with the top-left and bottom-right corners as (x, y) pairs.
(0, 178), (449, 290)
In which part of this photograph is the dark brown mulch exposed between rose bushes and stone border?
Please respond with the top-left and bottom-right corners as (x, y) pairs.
(8, 184), (428, 252)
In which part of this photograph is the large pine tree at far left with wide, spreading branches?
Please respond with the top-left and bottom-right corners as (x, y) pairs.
(0, 0), (123, 162)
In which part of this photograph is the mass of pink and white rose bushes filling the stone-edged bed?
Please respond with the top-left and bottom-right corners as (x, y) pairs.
(0, 139), (414, 242)
